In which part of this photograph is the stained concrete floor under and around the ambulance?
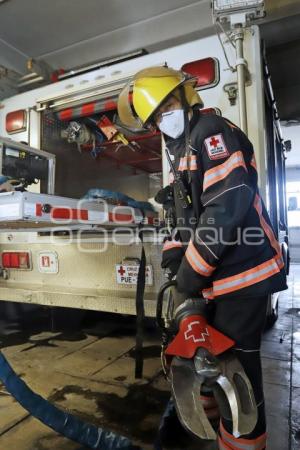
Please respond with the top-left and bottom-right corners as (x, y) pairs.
(0, 265), (300, 450)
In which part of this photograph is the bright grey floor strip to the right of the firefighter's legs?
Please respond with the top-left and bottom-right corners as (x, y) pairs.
(262, 264), (300, 450)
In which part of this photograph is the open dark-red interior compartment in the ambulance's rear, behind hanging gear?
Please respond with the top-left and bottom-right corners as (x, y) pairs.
(41, 101), (162, 206)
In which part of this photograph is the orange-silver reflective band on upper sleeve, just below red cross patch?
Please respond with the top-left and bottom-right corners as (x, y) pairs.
(203, 150), (247, 191)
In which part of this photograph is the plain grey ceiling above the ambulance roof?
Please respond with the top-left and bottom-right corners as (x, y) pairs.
(0, 0), (216, 71)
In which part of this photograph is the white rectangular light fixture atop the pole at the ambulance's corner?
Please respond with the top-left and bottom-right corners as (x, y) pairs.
(213, 0), (265, 26)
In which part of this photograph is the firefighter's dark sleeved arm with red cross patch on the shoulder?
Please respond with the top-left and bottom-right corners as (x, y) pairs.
(177, 121), (253, 295)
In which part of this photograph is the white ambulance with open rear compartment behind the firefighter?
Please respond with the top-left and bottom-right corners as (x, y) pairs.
(0, 7), (289, 321)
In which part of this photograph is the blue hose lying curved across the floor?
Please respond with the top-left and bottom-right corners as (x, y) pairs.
(0, 352), (140, 450)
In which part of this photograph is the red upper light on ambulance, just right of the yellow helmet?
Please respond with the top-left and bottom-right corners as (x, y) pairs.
(181, 58), (220, 90)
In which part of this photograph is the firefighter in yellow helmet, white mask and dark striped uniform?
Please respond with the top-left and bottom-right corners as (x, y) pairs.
(118, 67), (287, 450)
